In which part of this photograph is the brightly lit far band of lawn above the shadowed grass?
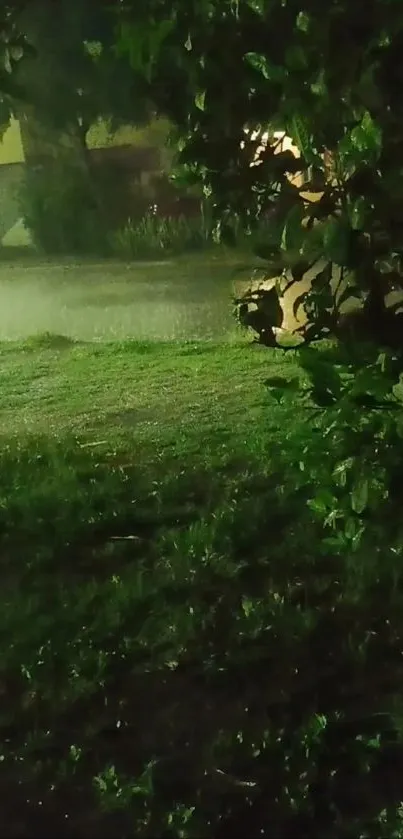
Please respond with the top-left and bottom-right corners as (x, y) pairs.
(0, 335), (298, 446)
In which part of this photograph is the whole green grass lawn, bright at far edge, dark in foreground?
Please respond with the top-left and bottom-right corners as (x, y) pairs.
(0, 336), (403, 839)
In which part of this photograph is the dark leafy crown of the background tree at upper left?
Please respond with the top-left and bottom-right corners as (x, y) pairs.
(11, 0), (155, 157)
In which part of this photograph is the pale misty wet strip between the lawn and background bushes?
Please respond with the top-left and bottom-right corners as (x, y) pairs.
(0, 249), (254, 341)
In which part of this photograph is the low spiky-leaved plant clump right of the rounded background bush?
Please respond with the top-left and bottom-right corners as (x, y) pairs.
(109, 208), (211, 259)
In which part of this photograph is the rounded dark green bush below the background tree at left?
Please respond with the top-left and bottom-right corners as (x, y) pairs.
(20, 161), (108, 255)
